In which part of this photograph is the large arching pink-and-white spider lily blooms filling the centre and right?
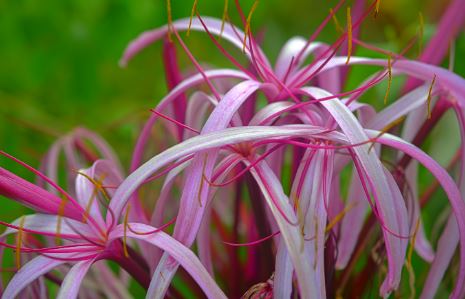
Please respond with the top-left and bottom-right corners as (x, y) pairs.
(117, 1), (465, 298)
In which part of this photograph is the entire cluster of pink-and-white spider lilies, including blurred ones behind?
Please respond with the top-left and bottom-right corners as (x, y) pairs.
(0, 0), (465, 299)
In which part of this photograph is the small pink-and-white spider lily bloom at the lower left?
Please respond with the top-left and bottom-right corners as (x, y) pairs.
(0, 152), (224, 299)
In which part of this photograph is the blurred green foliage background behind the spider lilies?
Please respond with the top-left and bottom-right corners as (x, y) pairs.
(0, 0), (465, 296)
